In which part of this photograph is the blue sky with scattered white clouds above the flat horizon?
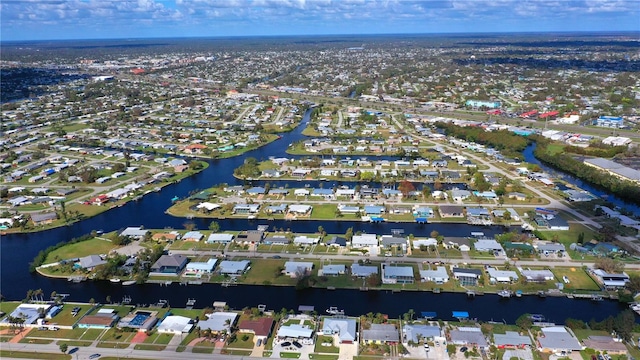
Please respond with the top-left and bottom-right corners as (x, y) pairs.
(0, 0), (640, 41)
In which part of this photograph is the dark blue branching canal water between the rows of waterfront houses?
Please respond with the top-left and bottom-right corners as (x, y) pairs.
(0, 112), (636, 322)
